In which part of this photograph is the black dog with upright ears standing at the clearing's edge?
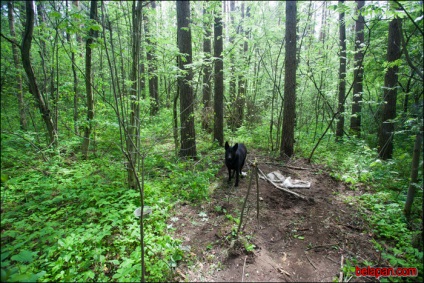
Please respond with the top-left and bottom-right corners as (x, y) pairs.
(225, 142), (247, 187)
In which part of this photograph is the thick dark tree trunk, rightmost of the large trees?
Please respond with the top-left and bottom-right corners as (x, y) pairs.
(378, 6), (401, 160)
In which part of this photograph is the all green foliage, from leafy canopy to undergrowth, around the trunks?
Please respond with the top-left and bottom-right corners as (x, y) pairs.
(0, 1), (423, 281)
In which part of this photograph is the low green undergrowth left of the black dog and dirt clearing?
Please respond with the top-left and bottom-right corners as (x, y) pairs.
(1, 123), (222, 282)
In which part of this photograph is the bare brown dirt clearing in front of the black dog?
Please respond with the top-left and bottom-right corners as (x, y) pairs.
(169, 152), (379, 282)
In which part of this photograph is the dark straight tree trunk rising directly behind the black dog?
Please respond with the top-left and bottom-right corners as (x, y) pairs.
(213, 4), (224, 146)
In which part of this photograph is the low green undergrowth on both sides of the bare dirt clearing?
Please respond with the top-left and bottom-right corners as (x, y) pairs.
(1, 110), (423, 282)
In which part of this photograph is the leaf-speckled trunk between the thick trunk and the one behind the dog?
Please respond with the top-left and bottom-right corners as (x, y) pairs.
(202, 2), (212, 132)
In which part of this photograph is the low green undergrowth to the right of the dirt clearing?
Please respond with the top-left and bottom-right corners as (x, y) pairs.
(298, 137), (424, 281)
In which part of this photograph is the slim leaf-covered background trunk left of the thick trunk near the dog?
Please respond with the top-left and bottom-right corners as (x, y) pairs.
(144, 1), (159, 116)
